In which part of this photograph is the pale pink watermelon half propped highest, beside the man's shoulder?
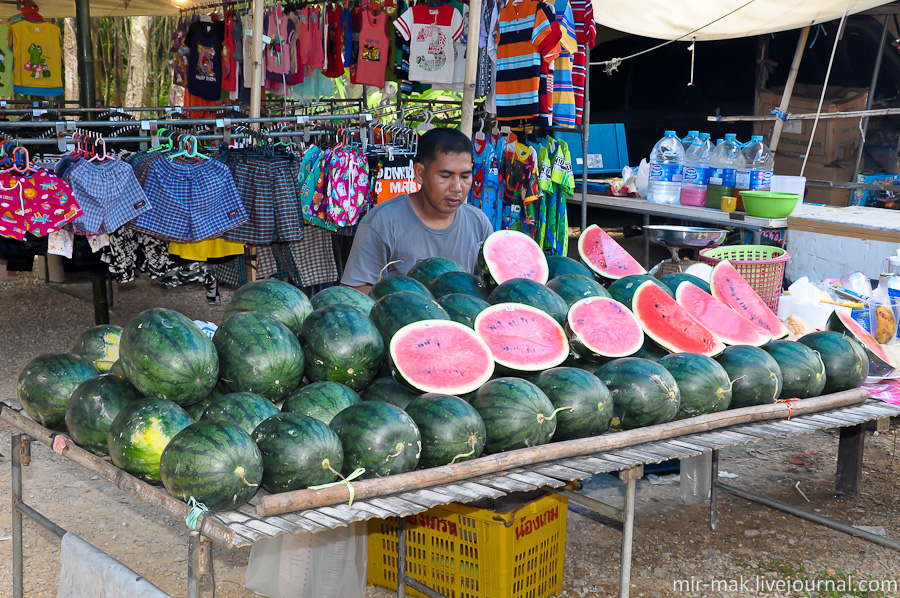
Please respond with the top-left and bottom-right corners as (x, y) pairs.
(478, 230), (550, 284)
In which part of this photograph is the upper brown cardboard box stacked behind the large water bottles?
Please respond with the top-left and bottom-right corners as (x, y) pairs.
(753, 84), (869, 164)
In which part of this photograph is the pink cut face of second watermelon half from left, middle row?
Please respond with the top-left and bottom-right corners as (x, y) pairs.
(475, 303), (569, 372)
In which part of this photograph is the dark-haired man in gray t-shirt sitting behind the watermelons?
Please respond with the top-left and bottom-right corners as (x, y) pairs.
(341, 129), (493, 293)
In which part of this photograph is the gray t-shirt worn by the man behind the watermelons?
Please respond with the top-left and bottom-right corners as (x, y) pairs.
(341, 195), (493, 287)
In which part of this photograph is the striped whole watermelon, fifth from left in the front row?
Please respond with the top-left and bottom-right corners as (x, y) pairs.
(472, 378), (556, 455)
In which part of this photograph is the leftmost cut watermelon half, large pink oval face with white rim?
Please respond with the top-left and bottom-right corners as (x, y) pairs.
(390, 320), (494, 395)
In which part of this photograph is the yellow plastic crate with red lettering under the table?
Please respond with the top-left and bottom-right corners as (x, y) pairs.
(368, 494), (568, 598)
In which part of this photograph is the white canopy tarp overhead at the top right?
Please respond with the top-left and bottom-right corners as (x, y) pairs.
(593, 0), (890, 41)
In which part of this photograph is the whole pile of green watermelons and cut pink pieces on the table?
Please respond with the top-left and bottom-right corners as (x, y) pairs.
(18, 227), (894, 509)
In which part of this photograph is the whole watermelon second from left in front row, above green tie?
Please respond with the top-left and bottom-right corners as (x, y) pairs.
(252, 412), (344, 492)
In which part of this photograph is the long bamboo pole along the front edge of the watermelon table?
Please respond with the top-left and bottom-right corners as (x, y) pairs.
(256, 388), (869, 516)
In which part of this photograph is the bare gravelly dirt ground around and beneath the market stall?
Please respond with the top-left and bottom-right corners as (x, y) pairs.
(0, 276), (900, 598)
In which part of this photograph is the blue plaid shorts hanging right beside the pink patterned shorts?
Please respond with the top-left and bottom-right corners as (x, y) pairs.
(68, 160), (151, 234)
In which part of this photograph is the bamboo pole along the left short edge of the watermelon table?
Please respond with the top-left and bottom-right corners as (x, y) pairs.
(0, 402), (237, 548)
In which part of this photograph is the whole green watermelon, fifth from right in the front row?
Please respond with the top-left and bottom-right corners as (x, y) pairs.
(595, 357), (681, 430)
